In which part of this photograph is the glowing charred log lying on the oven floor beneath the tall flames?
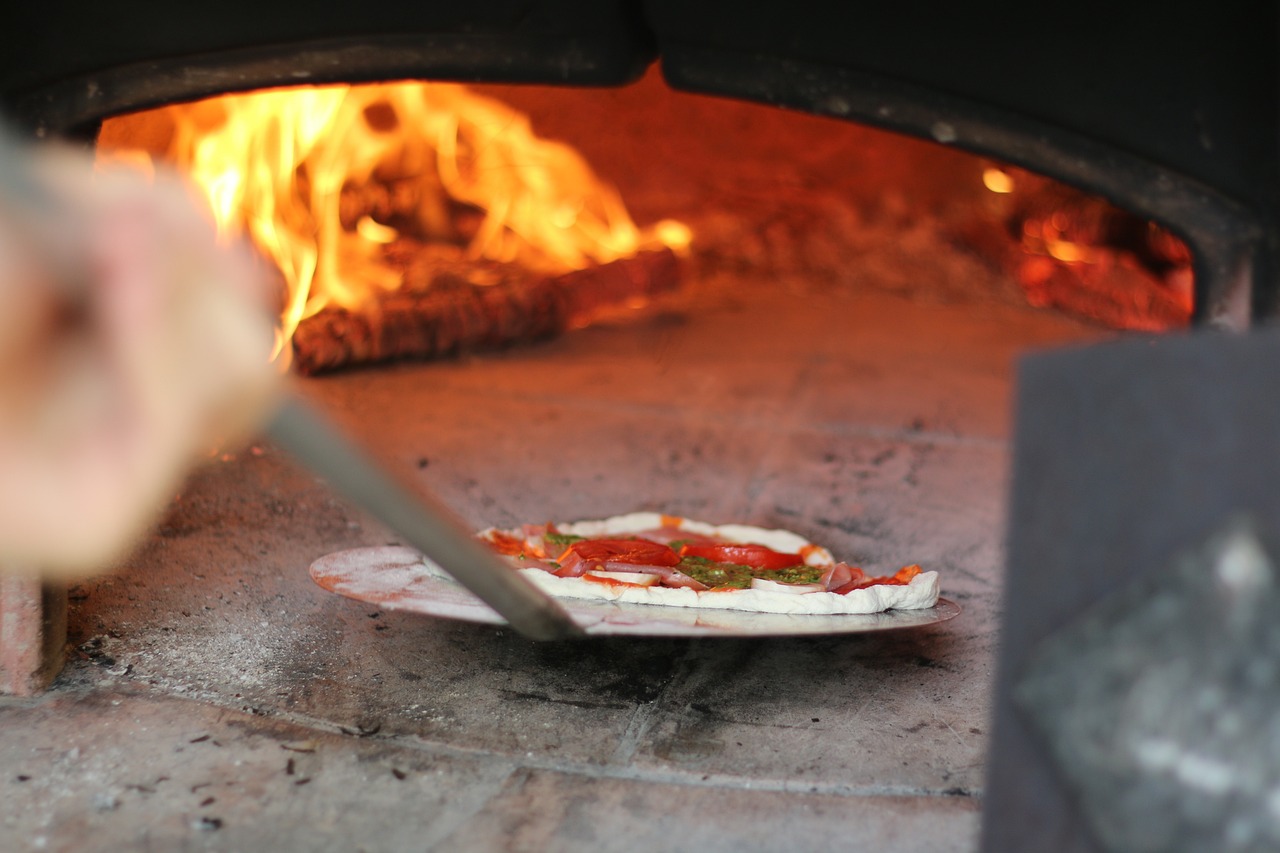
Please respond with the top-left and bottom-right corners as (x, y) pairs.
(293, 248), (680, 375)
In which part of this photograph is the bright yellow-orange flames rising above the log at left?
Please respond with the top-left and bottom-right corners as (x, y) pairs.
(100, 83), (690, 361)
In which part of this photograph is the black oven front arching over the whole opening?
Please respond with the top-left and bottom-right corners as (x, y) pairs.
(0, 0), (1280, 319)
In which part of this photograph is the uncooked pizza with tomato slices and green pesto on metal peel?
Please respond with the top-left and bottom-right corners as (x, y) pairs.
(479, 512), (938, 615)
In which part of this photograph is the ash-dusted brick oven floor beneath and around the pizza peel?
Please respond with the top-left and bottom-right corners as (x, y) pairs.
(0, 275), (1100, 853)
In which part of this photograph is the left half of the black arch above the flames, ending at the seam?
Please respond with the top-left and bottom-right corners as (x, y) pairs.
(0, 0), (654, 133)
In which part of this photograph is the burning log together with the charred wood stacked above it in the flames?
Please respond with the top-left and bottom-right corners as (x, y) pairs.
(293, 144), (680, 375)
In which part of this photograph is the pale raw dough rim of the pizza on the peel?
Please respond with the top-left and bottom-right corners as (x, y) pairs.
(471, 512), (938, 615)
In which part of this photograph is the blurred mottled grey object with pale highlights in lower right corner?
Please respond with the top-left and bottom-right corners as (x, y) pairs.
(1014, 523), (1280, 853)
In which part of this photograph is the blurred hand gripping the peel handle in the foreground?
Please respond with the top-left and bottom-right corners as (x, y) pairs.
(0, 140), (276, 575)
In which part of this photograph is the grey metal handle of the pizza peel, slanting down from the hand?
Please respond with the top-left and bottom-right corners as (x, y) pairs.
(266, 396), (582, 640)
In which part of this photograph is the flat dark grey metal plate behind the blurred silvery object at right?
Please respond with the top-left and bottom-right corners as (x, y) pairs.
(983, 329), (1280, 853)
